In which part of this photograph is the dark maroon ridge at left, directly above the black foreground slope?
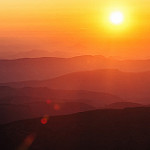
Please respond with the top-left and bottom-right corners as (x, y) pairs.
(0, 102), (96, 124)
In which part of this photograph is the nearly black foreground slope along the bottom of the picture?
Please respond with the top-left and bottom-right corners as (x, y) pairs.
(0, 108), (150, 150)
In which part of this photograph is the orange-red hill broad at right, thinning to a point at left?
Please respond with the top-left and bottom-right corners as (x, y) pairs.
(2, 69), (150, 100)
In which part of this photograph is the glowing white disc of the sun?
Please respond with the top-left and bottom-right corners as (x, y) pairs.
(110, 11), (124, 25)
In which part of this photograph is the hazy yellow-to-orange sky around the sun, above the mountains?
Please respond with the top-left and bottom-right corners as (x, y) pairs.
(0, 0), (150, 58)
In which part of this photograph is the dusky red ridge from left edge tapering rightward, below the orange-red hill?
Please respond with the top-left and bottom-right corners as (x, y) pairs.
(0, 87), (123, 107)
